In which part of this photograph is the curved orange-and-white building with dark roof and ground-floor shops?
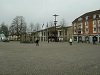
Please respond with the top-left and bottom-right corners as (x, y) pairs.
(72, 10), (100, 43)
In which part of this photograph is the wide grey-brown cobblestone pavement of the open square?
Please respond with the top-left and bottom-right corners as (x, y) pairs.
(0, 42), (100, 75)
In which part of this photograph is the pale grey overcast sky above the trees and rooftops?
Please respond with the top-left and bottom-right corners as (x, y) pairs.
(0, 0), (100, 25)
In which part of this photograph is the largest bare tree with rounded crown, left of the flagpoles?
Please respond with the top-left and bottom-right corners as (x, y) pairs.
(10, 16), (27, 40)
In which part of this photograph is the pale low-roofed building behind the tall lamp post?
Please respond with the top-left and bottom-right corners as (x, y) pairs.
(35, 25), (72, 42)
